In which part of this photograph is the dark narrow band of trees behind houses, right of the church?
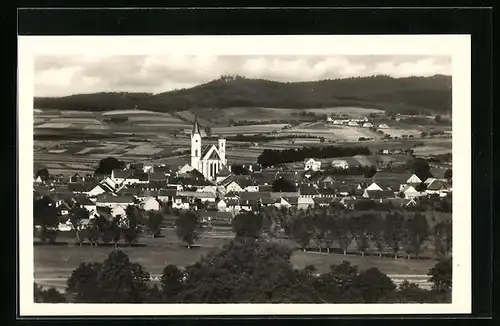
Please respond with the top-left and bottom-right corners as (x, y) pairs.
(257, 146), (371, 167)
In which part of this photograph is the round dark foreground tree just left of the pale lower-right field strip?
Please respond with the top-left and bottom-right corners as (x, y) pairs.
(356, 267), (396, 303)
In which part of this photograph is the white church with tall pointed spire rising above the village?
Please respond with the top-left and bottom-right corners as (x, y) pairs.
(191, 117), (227, 180)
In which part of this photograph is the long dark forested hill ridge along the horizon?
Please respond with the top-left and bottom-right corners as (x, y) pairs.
(34, 75), (451, 113)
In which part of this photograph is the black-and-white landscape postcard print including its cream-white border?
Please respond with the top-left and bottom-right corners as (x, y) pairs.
(18, 35), (471, 315)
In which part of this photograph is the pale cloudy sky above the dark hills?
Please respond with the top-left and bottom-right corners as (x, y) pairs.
(34, 55), (452, 96)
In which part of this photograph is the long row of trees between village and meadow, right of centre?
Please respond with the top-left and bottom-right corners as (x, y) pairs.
(233, 207), (452, 259)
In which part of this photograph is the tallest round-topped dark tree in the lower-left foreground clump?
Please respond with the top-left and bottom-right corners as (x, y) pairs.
(97, 250), (150, 303)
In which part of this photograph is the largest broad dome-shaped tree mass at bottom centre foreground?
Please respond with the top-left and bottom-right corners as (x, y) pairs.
(178, 238), (322, 303)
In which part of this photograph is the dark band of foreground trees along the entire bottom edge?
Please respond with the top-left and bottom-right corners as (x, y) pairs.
(34, 242), (452, 303)
